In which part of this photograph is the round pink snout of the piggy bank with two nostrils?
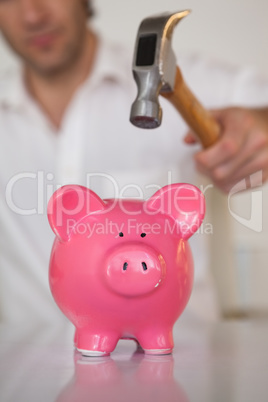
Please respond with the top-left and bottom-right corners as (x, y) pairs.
(105, 243), (166, 296)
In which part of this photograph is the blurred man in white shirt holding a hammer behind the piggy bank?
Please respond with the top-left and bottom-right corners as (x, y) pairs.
(0, 0), (268, 322)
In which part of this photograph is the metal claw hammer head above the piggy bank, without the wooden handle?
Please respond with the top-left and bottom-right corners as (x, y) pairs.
(130, 10), (190, 128)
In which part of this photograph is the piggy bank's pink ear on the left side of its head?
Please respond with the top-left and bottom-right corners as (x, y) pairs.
(47, 185), (105, 241)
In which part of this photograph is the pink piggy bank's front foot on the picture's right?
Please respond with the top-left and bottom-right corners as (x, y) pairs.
(137, 328), (174, 355)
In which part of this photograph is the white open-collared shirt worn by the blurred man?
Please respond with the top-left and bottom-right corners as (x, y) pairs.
(0, 37), (268, 322)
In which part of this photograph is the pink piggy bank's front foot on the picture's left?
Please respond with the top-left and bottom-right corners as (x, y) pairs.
(75, 328), (120, 357)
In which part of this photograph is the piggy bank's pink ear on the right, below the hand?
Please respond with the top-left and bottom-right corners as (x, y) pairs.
(145, 183), (205, 240)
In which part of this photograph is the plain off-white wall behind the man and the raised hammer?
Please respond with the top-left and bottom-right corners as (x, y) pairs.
(0, 0), (268, 76)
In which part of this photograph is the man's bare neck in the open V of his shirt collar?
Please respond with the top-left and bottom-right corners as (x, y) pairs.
(25, 32), (97, 130)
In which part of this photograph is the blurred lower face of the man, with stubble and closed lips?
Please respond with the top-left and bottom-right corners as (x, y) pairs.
(0, 0), (88, 75)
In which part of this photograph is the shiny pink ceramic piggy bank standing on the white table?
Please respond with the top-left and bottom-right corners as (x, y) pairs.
(48, 184), (205, 356)
